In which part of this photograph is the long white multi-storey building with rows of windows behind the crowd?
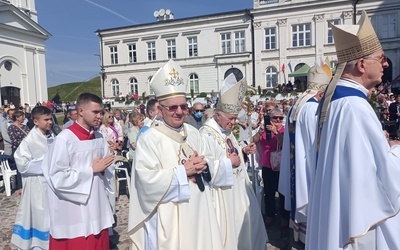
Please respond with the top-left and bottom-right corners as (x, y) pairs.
(97, 0), (400, 97)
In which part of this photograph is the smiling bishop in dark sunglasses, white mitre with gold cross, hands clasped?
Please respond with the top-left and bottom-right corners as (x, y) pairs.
(128, 60), (223, 250)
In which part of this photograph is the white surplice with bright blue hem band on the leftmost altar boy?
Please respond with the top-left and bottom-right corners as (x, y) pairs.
(11, 126), (53, 249)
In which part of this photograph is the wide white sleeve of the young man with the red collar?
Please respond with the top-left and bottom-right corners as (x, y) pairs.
(45, 136), (93, 204)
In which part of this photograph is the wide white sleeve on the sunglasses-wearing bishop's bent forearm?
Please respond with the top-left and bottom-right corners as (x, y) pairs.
(162, 165), (190, 203)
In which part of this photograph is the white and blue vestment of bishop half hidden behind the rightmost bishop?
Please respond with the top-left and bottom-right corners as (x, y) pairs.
(278, 97), (318, 242)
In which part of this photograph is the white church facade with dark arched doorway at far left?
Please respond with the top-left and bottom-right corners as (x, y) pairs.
(0, 0), (51, 106)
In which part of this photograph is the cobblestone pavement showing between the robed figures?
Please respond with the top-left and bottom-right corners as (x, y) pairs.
(0, 188), (302, 250)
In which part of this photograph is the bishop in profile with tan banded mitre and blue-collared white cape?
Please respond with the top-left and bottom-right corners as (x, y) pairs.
(306, 11), (400, 250)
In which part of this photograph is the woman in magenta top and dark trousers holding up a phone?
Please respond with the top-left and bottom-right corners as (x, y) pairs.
(253, 108), (289, 229)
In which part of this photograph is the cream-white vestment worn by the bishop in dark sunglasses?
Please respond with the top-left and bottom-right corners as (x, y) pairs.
(128, 123), (223, 250)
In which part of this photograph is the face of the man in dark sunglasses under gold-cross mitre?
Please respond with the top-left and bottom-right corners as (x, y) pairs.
(159, 96), (188, 128)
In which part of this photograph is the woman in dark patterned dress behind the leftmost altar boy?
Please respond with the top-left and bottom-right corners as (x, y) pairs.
(7, 110), (29, 194)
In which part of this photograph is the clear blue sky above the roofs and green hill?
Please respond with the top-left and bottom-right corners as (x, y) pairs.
(36, 0), (253, 87)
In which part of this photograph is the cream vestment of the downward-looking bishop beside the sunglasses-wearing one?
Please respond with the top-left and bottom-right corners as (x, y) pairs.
(200, 118), (268, 250)
